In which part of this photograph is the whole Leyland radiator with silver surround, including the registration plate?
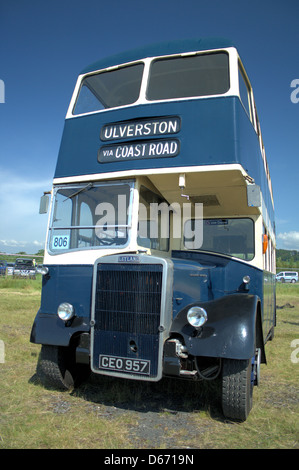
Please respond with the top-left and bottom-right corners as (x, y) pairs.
(91, 254), (173, 381)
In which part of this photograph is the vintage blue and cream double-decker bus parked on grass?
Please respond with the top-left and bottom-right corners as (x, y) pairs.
(31, 39), (275, 420)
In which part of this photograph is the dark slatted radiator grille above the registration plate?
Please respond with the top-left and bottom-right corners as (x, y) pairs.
(95, 263), (163, 335)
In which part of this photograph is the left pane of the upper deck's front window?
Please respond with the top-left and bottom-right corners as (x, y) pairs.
(74, 63), (144, 114)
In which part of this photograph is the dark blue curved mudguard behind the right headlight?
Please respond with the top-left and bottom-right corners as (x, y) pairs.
(171, 293), (265, 359)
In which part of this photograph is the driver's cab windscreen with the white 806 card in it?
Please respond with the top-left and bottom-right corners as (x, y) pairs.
(49, 182), (133, 253)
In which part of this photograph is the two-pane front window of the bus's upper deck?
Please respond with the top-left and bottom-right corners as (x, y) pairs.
(73, 51), (230, 115)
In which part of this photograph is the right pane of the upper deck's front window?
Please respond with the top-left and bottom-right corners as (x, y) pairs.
(147, 52), (229, 100)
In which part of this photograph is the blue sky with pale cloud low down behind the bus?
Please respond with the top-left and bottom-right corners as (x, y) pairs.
(0, 0), (299, 254)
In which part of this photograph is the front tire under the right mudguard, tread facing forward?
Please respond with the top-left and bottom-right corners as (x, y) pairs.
(222, 359), (253, 421)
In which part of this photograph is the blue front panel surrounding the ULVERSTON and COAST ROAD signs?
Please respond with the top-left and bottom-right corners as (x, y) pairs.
(55, 97), (239, 178)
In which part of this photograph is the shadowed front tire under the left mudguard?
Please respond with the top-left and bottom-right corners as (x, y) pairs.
(36, 345), (75, 390)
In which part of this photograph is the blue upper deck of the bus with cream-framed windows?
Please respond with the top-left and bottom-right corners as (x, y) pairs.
(54, 40), (272, 205)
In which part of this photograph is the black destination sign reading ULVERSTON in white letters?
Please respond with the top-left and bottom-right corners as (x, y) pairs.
(100, 117), (181, 141)
